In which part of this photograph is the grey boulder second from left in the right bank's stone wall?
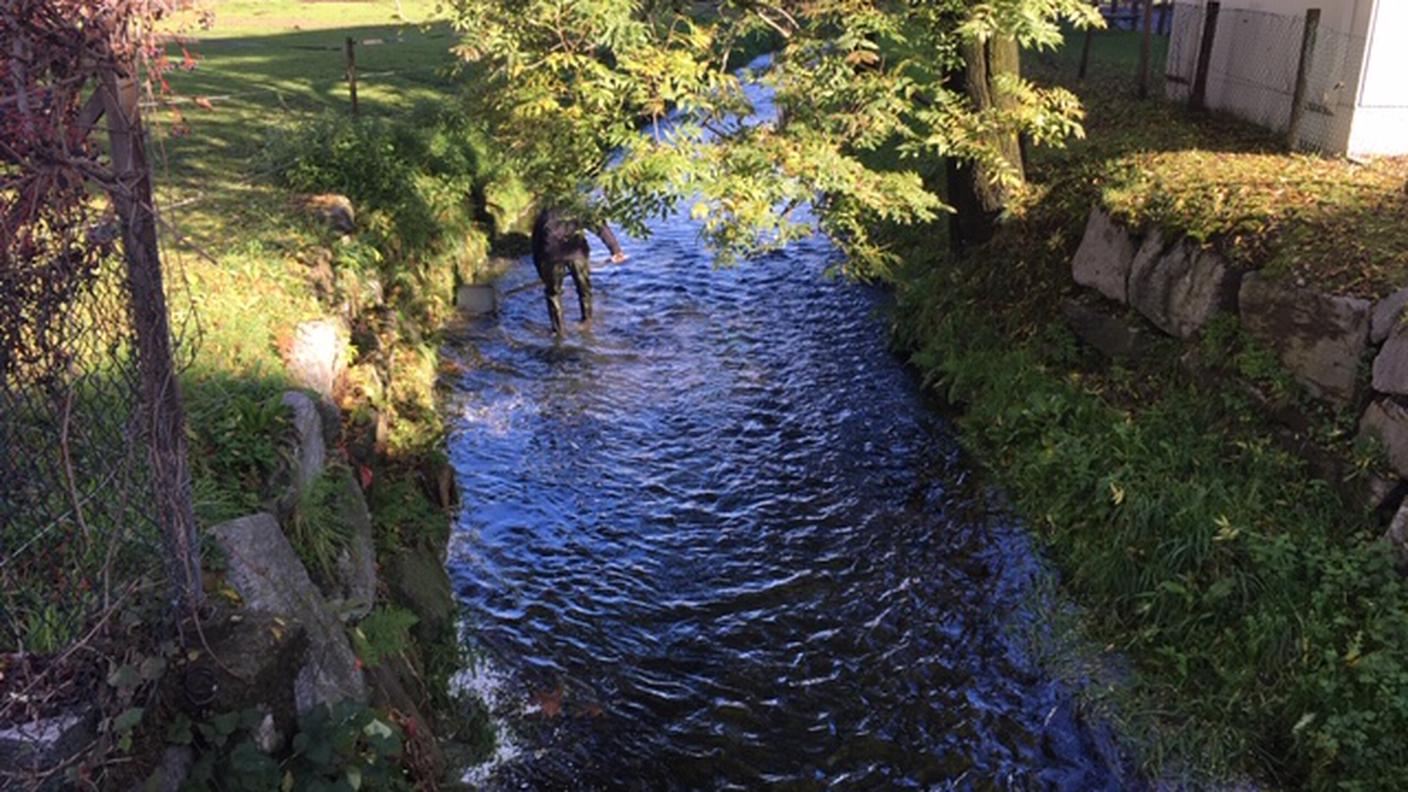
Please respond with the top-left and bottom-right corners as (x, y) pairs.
(1129, 231), (1242, 338)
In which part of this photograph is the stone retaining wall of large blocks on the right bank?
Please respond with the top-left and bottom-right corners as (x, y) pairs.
(1063, 207), (1408, 559)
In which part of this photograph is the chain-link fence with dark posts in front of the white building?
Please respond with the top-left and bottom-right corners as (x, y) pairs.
(1166, 0), (1364, 154)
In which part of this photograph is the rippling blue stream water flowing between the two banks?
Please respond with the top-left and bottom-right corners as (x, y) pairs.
(448, 60), (1132, 789)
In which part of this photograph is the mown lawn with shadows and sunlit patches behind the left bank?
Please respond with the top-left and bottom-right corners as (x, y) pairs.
(149, 0), (473, 523)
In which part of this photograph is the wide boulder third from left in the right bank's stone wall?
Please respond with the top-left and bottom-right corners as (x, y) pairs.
(1239, 273), (1369, 404)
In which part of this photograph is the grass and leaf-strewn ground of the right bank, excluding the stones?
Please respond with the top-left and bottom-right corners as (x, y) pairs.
(897, 32), (1408, 789)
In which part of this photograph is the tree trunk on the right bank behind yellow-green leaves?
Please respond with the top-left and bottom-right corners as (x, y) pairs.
(948, 38), (1026, 251)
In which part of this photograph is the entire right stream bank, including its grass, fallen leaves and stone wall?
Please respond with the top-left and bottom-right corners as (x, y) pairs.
(893, 34), (1408, 789)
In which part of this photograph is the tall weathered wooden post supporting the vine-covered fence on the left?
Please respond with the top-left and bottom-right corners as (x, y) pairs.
(97, 65), (203, 616)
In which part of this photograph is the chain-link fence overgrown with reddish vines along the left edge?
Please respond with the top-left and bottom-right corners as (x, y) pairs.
(0, 0), (200, 789)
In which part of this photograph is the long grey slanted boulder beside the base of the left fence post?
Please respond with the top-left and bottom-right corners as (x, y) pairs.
(210, 514), (366, 714)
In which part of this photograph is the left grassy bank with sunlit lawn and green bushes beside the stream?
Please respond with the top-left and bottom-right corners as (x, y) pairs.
(130, 0), (527, 788)
